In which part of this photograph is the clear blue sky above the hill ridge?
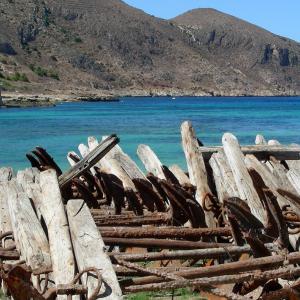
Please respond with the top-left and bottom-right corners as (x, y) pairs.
(125, 0), (300, 41)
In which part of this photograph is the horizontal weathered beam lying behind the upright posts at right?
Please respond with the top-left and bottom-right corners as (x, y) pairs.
(199, 145), (300, 161)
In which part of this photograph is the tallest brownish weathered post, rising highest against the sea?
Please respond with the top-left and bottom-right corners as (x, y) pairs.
(181, 122), (215, 227)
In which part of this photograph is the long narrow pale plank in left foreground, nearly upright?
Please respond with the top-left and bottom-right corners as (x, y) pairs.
(40, 170), (75, 299)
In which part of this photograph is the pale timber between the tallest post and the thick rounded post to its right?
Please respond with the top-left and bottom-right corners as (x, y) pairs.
(209, 150), (239, 203)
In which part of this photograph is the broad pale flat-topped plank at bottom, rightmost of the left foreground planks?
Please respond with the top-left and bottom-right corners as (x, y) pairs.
(67, 200), (122, 300)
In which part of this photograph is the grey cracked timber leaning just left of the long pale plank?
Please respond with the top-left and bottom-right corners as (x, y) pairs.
(7, 179), (51, 269)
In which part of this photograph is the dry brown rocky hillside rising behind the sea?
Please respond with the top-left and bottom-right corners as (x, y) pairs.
(0, 0), (300, 95)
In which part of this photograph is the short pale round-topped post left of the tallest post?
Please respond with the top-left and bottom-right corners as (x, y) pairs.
(137, 145), (166, 179)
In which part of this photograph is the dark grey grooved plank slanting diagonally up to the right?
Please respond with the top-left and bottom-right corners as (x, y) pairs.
(59, 135), (119, 188)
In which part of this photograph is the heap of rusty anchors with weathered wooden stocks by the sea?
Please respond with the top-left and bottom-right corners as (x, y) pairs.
(0, 122), (300, 300)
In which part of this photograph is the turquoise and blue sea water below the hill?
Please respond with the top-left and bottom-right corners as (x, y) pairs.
(0, 97), (300, 170)
